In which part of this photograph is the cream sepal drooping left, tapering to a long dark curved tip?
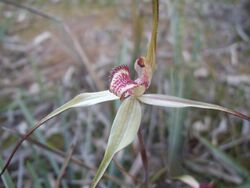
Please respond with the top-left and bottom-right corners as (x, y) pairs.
(0, 90), (119, 176)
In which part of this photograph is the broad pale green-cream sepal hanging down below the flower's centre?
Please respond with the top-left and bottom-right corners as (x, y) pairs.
(91, 97), (141, 188)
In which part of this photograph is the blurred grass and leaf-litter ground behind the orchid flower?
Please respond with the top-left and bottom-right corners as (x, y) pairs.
(0, 0), (250, 188)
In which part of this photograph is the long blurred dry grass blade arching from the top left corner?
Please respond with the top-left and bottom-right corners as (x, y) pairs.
(0, 0), (105, 90)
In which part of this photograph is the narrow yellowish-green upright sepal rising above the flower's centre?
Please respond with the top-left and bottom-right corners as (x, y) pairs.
(146, 0), (159, 71)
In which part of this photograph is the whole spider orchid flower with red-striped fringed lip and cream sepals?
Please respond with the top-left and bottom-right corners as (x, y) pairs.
(0, 0), (250, 188)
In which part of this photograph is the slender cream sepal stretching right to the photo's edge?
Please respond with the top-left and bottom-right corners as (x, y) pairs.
(138, 94), (250, 121)
